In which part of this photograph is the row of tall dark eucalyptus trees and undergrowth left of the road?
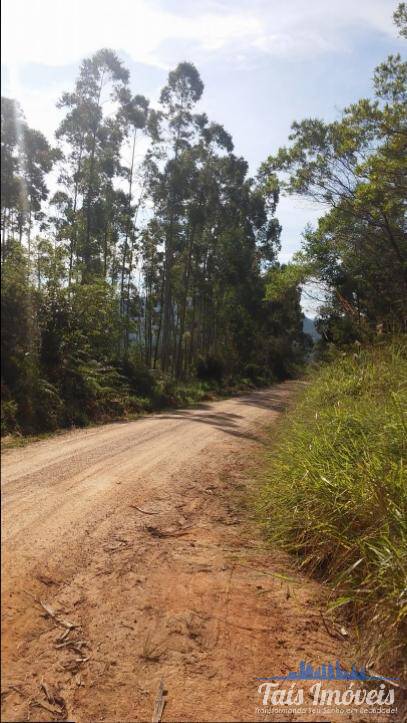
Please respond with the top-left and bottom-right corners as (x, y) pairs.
(1, 56), (305, 432)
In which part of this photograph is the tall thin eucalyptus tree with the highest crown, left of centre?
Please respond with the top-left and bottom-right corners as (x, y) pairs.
(57, 49), (129, 279)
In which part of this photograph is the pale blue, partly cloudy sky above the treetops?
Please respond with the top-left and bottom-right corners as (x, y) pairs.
(2, 0), (403, 314)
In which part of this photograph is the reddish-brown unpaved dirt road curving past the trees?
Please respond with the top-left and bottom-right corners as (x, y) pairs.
(2, 383), (354, 723)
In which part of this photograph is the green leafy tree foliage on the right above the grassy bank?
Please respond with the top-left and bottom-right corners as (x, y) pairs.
(260, 14), (407, 343)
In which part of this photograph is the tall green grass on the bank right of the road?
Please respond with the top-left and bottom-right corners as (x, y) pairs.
(260, 341), (407, 664)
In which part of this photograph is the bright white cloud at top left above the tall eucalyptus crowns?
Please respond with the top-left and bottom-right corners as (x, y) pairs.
(3, 0), (260, 66)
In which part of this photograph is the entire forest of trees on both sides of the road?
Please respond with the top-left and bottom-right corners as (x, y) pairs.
(1, 3), (407, 433)
